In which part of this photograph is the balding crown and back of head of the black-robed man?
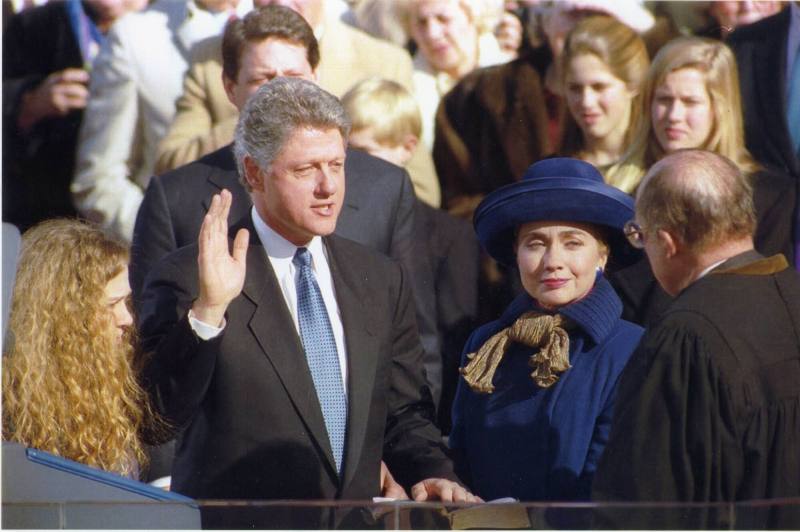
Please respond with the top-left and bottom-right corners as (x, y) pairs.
(636, 150), (756, 254)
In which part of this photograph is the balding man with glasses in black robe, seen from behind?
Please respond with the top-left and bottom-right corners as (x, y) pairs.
(592, 150), (800, 529)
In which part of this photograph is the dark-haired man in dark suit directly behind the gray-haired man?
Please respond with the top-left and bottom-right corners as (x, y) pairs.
(130, 6), (439, 378)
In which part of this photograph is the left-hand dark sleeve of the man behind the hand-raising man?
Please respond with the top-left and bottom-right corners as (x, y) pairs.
(130, 176), (177, 309)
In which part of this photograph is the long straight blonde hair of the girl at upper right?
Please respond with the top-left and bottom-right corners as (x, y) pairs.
(606, 37), (759, 193)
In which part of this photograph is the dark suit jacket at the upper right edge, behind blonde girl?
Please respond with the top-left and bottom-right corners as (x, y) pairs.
(727, 8), (800, 179)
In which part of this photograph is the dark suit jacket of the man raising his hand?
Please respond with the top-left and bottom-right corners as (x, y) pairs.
(140, 215), (455, 528)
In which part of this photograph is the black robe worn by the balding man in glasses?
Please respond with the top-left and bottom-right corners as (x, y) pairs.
(592, 252), (800, 529)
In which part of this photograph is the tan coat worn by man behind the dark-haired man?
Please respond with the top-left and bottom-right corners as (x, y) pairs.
(156, 0), (440, 207)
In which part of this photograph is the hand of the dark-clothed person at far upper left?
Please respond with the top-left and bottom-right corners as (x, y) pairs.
(17, 68), (89, 131)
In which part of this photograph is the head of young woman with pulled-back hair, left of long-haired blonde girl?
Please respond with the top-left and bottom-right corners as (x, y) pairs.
(561, 16), (650, 171)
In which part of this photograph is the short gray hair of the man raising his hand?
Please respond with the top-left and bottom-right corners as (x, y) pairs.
(233, 78), (350, 192)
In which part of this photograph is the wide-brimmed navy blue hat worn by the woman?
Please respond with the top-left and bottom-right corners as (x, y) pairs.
(473, 157), (638, 266)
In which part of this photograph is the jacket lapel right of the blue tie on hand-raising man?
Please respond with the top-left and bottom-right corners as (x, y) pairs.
(325, 236), (379, 486)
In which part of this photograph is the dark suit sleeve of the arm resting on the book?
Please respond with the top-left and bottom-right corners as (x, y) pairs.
(383, 260), (458, 486)
